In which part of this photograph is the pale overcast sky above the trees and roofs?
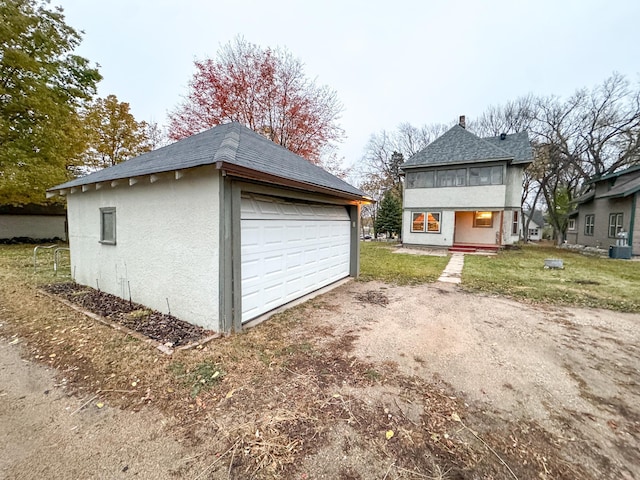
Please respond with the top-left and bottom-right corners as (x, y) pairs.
(57, 0), (640, 172)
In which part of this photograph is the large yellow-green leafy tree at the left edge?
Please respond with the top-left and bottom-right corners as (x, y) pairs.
(0, 0), (102, 205)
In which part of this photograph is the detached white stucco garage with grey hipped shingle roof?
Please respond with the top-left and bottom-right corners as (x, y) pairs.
(49, 123), (369, 332)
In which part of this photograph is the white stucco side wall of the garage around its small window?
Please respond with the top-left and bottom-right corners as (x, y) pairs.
(67, 167), (220, 331)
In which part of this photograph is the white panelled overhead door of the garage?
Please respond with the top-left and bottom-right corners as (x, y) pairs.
(240, 196), (351, 322)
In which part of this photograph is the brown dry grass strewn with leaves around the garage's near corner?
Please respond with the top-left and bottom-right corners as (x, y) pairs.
(0, 247), (589, 479)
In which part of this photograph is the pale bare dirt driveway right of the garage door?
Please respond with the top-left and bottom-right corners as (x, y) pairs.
(326, 283), (640, 479)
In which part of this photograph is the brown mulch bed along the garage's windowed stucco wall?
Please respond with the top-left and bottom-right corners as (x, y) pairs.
(42, 283), (214, 348)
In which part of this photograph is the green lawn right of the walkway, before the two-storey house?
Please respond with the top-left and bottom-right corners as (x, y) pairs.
(462, 246), (640, 312)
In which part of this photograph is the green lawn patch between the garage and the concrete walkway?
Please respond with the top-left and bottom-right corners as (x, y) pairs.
(360, 242), (449, 285)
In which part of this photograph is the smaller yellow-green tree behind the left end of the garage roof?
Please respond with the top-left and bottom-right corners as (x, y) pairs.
(84, 95), (153, 170)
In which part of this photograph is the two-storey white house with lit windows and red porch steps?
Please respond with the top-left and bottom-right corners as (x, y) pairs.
(401, 117), (533, 251)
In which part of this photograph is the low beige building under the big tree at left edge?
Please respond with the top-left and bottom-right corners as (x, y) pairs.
(0, 205), (67, 241)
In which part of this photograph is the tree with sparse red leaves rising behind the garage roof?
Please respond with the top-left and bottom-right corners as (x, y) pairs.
(169, 37), (344, 163)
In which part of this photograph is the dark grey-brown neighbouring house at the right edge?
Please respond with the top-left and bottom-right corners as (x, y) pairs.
(566, 166), (640, 255)
